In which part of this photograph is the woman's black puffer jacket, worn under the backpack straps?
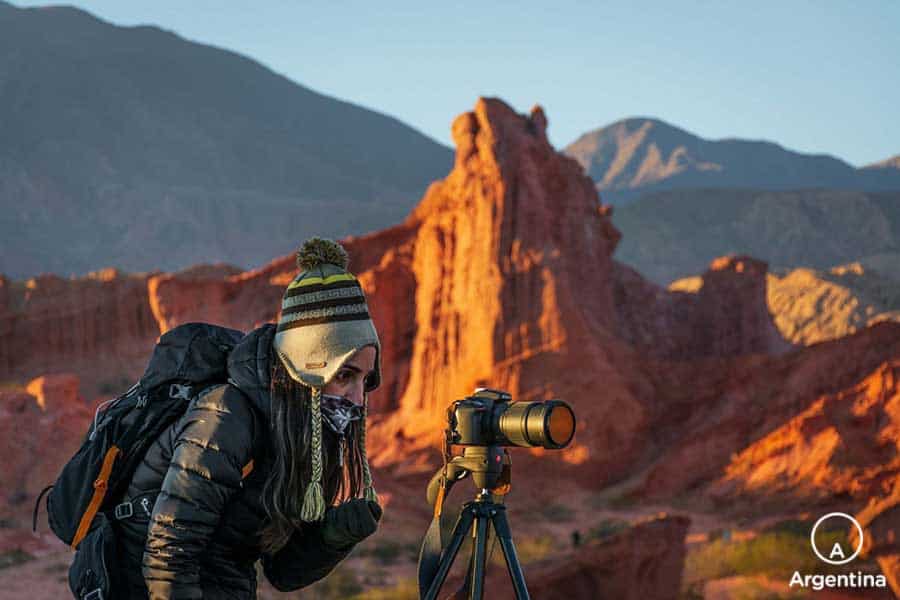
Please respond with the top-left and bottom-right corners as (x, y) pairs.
(116, 324), (350, 600)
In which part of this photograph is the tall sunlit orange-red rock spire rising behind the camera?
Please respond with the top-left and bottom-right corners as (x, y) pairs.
(390, 99), (618, 436)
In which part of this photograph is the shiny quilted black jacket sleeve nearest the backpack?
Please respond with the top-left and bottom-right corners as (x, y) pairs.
(142, 386), (253, 600)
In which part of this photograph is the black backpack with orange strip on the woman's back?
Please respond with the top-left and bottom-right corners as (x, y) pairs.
(32, 323), (255, 600)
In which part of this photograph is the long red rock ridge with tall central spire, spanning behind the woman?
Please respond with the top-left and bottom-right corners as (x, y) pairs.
(0, 99), (900, 544)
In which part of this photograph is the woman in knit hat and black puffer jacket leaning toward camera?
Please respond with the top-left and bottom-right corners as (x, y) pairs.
(117, 238), (381, 600)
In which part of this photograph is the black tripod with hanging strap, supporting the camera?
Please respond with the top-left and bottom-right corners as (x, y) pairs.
(419, 446), (530, 600)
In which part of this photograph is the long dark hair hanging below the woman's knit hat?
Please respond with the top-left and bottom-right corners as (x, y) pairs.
(260, 351), (363, 553)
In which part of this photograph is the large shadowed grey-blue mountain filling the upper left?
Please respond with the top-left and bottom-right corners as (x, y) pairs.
(0, 2), (453, 278)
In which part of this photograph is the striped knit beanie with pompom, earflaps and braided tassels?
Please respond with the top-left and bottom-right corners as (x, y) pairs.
(273, 237), (381, 522)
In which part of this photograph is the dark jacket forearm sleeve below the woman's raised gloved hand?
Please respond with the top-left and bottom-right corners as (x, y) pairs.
(261, 522), (353, 592)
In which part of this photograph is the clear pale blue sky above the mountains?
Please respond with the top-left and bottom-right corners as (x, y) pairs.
(15, 0), (900, 166)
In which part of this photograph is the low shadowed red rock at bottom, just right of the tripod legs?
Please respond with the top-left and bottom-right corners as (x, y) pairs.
(441, 517), (690, 600)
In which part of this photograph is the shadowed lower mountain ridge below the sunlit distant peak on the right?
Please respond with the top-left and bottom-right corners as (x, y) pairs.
(613, 189), (900, 288)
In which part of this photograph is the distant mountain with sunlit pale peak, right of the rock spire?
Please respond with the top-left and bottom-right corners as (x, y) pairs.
(564, 118), (900, 204)
